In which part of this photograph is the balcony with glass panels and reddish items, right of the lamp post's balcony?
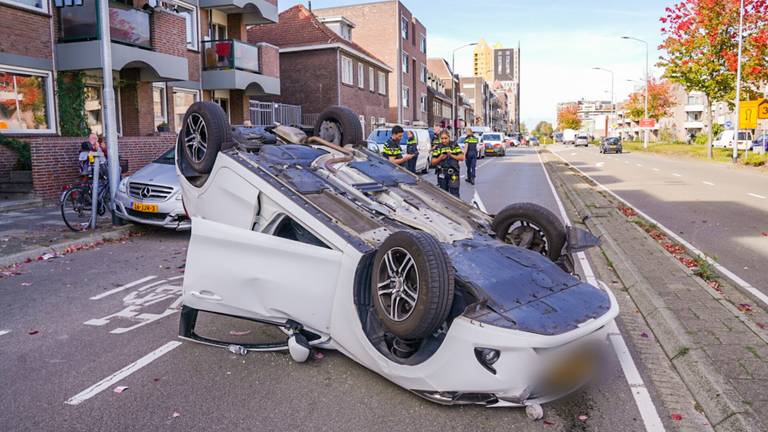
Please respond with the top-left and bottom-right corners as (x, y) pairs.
(200, 39), (280, 95)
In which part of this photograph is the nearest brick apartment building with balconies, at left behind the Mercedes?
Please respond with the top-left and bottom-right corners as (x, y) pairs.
(0, 0), (279, 199)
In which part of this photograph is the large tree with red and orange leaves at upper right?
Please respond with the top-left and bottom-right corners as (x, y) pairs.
(659, 0), (768, 158)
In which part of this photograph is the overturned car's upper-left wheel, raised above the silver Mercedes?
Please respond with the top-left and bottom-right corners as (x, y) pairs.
(179, 102), (232, 175)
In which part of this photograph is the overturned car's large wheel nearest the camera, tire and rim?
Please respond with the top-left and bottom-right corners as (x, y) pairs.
(371, 231), (454, 340)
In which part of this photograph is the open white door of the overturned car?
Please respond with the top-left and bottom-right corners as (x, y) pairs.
(183, 216), (343, 331)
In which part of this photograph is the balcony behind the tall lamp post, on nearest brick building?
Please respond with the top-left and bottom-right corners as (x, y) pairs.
(56, 1), (189, 81)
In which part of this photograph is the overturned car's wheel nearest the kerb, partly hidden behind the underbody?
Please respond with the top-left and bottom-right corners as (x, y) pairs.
(492, 203), (566, 261)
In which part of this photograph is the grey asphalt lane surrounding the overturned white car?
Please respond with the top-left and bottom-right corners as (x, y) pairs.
(0, 150), (664, 432)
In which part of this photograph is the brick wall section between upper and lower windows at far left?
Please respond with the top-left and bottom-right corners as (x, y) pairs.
(0, 4), (53, 59)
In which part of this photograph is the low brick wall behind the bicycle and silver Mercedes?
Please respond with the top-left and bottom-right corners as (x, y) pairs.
(29, 133), (176, 200)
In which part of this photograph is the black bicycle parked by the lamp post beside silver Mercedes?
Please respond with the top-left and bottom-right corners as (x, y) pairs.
(60, 160), (111, 232)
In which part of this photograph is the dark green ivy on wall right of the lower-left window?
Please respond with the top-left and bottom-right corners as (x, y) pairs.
(56, 72), (89, 137)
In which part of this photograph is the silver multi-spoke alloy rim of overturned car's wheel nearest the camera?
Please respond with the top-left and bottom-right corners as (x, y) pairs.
(376, 248), (419, 322)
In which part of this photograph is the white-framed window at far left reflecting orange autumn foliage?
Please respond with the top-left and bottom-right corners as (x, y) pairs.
(0, 67), (56, 133)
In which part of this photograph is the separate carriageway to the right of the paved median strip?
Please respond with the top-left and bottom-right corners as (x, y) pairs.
(548, 145), (768, 294)
